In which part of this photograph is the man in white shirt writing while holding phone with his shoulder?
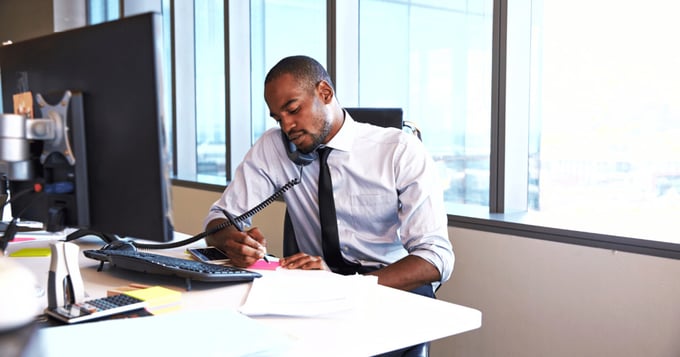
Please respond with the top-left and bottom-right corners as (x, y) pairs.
(205, 56), (454, 296)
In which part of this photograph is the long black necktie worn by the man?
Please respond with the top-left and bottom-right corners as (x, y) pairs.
(319, 147), (344, 271)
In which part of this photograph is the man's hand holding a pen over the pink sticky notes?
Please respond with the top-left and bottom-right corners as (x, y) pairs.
(205, 219), (267, 268)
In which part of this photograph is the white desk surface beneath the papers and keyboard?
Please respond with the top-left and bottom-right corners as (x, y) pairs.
(8, 232), (481, 356)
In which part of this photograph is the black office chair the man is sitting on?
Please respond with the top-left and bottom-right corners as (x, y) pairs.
(283, 108), (434, 357)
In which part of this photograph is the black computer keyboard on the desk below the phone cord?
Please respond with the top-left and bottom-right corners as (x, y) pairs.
(83, 249), (262, 290)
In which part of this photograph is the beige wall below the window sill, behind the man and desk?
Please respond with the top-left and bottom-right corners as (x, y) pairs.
(173, 187), (680, 357)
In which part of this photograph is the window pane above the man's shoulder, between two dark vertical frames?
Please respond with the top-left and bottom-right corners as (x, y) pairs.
(354, 0), (492, 207)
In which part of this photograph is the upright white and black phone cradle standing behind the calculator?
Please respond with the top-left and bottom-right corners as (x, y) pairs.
(47, 242), (85, 309)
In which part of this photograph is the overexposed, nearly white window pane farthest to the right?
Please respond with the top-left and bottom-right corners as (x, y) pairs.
(505, 0), (680, 242)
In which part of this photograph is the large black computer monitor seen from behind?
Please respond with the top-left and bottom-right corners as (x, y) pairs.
(0, 13), (173, 242)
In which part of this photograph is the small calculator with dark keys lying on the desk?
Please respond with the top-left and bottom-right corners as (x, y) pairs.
(45, 294), (146, 324)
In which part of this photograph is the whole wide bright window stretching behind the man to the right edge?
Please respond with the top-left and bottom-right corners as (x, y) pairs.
(86, 0), (680, 257)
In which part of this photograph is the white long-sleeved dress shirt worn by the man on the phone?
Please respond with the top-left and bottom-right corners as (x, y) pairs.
(205, 114), (454, 285)
